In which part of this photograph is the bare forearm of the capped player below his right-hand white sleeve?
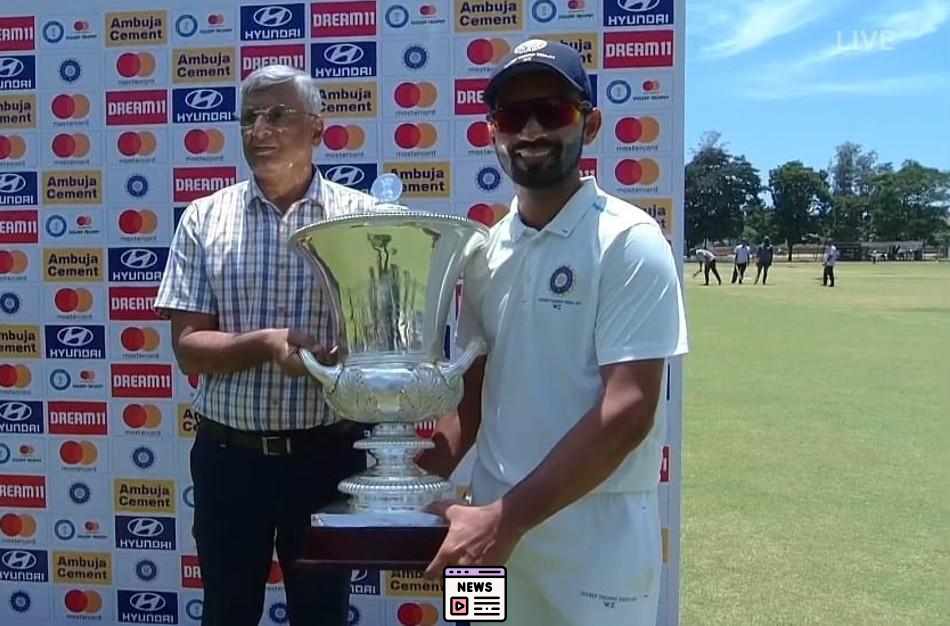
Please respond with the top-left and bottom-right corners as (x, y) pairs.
(502, 376), (656, 531)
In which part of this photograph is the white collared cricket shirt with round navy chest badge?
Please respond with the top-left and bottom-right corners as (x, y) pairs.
(457, 177), (687, 492)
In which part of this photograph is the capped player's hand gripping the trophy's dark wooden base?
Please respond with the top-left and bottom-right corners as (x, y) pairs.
(425, 500), (522, 580)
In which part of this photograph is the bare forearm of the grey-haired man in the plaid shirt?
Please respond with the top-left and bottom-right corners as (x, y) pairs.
(175, 329), (280, 374)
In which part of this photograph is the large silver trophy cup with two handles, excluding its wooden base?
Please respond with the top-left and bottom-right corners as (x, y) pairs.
(291, 174), (488, 517)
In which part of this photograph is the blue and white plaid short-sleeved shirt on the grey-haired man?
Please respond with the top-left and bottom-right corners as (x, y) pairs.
(155, 168), (375, 431)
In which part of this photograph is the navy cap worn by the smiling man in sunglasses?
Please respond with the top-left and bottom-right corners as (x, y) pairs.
(482, 39), (594, 108)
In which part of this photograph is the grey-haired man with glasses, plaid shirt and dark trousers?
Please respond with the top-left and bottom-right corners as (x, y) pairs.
(155, 66), (374, 626)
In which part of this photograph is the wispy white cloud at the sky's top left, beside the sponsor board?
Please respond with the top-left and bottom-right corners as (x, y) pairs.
(690, 0), (836, 58)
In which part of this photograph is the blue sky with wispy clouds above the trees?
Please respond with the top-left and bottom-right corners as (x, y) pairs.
(685, 0), (950, 177)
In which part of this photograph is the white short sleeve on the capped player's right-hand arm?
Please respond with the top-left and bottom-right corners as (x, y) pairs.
(594, 224), (688, 365)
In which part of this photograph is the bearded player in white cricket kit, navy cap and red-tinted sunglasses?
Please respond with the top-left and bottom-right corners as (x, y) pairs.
(420, 40), (687, 626)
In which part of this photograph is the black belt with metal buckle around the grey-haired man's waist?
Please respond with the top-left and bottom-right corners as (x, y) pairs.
(198, 418), (363, 456)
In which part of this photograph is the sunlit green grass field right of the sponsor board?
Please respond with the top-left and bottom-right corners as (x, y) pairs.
(681, 263), (950, 626)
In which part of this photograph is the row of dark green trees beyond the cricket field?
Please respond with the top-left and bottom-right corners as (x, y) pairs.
(685, 132), (950, 260)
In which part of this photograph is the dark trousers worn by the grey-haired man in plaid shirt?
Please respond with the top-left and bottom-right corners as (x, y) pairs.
(191, 425), (366, 626)
